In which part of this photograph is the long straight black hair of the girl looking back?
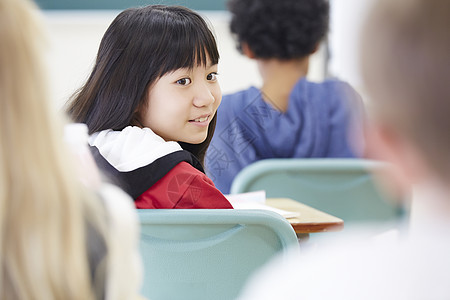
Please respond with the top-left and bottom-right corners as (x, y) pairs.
(67, 5), (219, 164)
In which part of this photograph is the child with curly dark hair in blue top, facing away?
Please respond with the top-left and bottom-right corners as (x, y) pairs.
(206, 0), (359, 193)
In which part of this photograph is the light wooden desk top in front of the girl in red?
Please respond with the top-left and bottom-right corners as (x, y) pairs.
(266, 198), (344, 233)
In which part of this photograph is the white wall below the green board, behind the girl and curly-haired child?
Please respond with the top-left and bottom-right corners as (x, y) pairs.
(44, 11), (325, 106)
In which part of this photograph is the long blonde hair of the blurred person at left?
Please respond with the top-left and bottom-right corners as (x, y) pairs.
(0, 0), (107, 300)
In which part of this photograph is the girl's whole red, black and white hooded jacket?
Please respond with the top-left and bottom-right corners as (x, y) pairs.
(90, 126), (233, 208)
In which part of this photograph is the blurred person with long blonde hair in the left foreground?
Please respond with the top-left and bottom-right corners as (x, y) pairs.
(0, 0), (141, 300)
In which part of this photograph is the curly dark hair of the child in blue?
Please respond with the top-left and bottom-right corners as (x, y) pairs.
(228, 0), (329, 59)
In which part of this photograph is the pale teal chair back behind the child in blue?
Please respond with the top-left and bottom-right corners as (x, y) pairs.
(231, 158), (406, 225)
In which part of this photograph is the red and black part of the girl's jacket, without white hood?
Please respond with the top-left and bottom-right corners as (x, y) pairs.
(91, 147), (233, 209)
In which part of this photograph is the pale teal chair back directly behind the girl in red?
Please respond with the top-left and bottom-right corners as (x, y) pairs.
(138, 209), (298, 300)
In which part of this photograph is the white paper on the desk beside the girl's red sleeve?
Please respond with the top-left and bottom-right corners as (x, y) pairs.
(225, 191), (300, 219)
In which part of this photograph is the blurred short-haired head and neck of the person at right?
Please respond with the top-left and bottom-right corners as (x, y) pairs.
(362, 0), (450, 193)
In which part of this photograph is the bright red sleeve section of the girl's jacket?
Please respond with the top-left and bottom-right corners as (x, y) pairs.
(135, 162), (233, 208)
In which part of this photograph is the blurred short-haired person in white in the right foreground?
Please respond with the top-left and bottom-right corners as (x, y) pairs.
(239, 0), (450, 300)
